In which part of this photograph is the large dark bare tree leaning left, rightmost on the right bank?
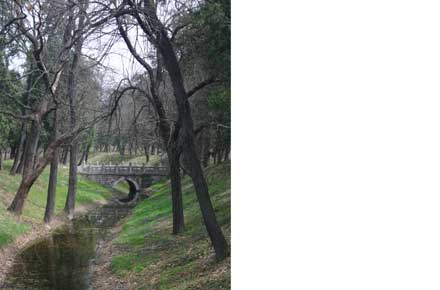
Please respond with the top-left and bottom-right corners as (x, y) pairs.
(105, 0), (229, 260)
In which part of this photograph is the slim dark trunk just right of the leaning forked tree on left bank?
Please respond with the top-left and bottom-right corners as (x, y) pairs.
(44, 110), (59, 223)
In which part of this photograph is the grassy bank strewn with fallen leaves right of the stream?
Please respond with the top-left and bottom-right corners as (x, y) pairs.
(111, 163), (231, 290)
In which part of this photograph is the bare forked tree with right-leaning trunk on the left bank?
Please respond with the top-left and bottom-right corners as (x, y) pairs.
(2, 1), (99, 215)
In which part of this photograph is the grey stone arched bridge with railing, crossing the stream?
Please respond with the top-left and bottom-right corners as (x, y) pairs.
(78, 164), (168, 191)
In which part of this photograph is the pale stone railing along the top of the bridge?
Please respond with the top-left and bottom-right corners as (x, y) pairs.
(78, 164), (168, 175)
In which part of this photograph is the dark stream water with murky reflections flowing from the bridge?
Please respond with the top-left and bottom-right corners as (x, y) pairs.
(1, 205), (129, 290)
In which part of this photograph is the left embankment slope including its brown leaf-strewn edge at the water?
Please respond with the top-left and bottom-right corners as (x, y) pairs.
(0, 160), (113, 284)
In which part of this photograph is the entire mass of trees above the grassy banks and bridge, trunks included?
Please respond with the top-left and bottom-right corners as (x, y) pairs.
(0, 0), (231, 260)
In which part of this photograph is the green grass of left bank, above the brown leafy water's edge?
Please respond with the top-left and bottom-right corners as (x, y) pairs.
(0, 160), (112, 247)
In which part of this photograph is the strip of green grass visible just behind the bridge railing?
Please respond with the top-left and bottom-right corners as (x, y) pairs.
(88, 152), (160, 166)
